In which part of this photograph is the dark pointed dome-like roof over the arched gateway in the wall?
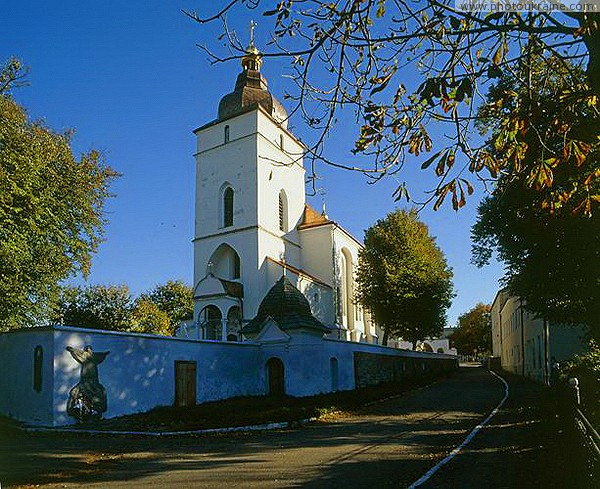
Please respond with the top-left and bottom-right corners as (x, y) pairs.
(242, 275), (329, 333)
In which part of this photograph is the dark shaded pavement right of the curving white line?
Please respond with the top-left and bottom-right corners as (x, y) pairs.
(421, 372), (600, 489)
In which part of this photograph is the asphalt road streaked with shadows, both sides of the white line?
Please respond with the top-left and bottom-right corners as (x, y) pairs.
(0, 368), (591, 489)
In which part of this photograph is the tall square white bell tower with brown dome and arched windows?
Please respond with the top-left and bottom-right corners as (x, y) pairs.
(194, 31), (305, 340)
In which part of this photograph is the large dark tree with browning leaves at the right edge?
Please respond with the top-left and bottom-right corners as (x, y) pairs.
(472, 60), (600, 335)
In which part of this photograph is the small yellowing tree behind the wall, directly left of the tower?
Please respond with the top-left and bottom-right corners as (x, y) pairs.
(140, 280), (194, 335)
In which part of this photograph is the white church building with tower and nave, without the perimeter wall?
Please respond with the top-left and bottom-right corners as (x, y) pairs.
(189, 43), (377, 343)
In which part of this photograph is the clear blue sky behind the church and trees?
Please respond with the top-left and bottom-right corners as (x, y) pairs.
(0, 0), (502, 325)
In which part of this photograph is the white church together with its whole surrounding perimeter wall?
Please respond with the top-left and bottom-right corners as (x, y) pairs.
(0, 38), (457, 426)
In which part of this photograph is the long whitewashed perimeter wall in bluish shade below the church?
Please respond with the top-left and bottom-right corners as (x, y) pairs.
(0, 326), (454, 426)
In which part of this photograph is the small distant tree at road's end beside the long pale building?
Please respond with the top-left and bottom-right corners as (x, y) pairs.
(450, 302), (492, 355)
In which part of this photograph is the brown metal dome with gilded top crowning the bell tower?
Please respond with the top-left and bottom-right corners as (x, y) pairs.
(219, 42), (288, 128)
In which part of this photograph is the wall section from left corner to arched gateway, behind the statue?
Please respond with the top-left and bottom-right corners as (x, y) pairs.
(53, 327), (264, 425)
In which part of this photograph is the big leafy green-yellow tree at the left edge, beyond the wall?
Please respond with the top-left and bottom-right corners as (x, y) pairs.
(0, 60), (117, 330)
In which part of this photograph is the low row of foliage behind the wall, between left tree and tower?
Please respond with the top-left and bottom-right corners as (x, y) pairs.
(52, 281), (193, 336)
